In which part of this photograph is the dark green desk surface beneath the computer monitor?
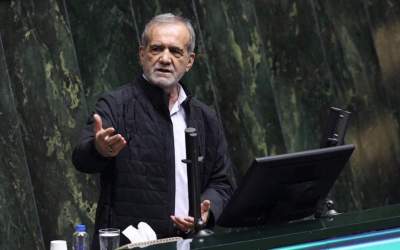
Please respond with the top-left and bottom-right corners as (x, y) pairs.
(140, 205), (400, 250)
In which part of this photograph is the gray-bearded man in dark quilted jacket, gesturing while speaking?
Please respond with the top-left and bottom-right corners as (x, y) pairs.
(73, 14), (233, 249)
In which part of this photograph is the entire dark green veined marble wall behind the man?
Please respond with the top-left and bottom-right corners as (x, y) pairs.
(0, 0), (400, 249)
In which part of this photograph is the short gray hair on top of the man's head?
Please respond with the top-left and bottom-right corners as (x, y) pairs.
(142, 13), (196, 52)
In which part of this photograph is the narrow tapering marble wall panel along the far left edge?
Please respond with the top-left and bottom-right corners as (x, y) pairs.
(0, 32), (44, 250)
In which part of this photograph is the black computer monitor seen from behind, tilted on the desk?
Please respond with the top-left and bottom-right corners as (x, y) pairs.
(217, 145), (354, 227)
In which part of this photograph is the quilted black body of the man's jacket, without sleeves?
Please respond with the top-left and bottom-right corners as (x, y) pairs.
(92, 77), (212, 249)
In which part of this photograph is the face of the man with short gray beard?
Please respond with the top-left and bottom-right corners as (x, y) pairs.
(139, 22), (194, 91)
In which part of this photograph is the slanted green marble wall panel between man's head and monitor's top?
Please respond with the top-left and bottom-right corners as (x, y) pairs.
(196, 1), (286, 176)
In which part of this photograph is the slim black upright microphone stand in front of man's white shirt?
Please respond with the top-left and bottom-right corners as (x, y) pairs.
(182, 127), (212, 237)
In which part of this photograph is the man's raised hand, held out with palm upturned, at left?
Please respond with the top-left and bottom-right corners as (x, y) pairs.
(93, 114), (126, 157)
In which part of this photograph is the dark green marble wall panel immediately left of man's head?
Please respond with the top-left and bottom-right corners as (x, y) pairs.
(66, 0), (140, 110)
